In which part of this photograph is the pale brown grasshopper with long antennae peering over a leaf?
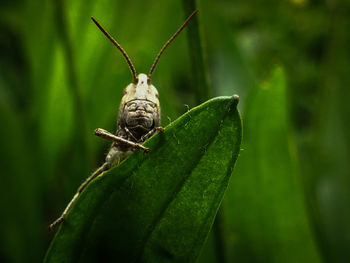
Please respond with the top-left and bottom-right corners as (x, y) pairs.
(49, 10), (198, 230)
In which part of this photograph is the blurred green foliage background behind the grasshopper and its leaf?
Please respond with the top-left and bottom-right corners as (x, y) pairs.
(0, 0), (350, 262)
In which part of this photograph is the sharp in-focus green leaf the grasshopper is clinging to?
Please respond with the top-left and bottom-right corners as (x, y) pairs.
(45, 97), (241, 262)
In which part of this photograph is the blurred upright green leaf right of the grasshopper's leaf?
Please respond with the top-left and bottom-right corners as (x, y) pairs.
(222, 68), (320, 263)
